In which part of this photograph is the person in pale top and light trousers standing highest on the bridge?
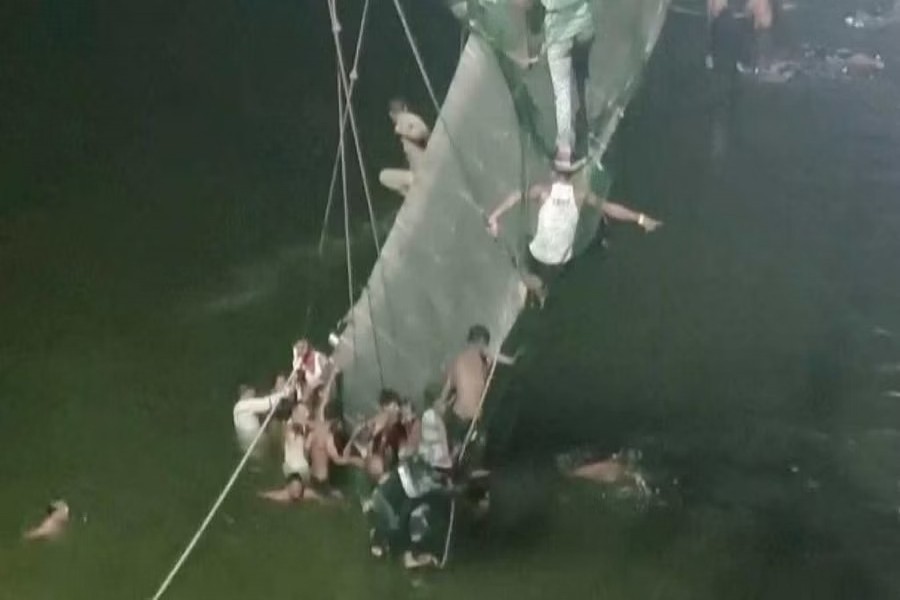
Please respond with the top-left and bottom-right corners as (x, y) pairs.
(541, 0), (594, 163)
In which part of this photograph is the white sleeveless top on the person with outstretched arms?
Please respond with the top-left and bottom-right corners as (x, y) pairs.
(528, 181), (580, 265)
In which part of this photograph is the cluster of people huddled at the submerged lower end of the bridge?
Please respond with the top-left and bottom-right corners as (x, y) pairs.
(233, 325), (513, 568)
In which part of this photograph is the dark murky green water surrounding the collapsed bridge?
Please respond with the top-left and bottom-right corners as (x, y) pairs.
(0, 2), (900, 600)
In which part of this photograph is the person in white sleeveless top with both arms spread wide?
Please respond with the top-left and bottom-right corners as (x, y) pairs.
(488, 164), (662, 306)
